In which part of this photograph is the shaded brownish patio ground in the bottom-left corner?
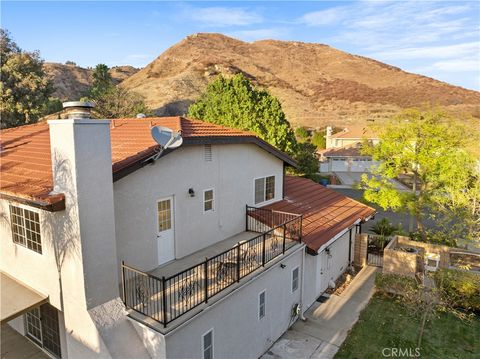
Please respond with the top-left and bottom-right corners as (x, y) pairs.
(0, 324), (50, 359)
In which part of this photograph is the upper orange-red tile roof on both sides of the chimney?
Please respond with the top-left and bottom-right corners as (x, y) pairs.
(0, 117), (294, 210)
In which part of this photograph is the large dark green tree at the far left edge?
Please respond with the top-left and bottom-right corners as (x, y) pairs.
(0, 29), (53, 128)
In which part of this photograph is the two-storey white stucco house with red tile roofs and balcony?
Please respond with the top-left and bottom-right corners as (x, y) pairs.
(0, 105), (374, 359)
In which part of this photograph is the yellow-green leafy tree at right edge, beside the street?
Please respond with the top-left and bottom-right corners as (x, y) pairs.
(362, 109), (479, 240)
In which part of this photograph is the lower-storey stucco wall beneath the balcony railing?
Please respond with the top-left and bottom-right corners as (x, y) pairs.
(166, 248), (303, 359)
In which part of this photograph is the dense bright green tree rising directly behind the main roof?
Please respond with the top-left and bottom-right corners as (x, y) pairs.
(188, 74), (297, 154)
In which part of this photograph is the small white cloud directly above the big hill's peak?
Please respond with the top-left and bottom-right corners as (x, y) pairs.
(190, 7), (263, 26)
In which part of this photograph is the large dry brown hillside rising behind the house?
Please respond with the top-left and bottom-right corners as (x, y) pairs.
(121, 34), (480, 127)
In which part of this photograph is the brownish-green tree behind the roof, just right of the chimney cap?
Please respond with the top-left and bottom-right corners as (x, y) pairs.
(88, 86), (152, 118)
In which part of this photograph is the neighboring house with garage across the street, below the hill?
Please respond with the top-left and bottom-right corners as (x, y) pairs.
(317, 126), (379, 173)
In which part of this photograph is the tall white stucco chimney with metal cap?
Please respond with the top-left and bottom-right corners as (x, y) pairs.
(48, 118), (118, 309)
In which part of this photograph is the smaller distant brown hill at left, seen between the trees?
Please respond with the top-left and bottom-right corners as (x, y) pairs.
(43, 62), (138, 101)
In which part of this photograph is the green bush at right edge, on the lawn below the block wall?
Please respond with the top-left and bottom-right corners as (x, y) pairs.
(434, 269), (480, 313)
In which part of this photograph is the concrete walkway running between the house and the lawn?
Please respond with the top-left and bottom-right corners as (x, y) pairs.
(261, 266), (377, 359)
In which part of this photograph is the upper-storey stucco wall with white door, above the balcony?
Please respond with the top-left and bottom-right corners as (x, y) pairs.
(114, 144), (283, 270)
